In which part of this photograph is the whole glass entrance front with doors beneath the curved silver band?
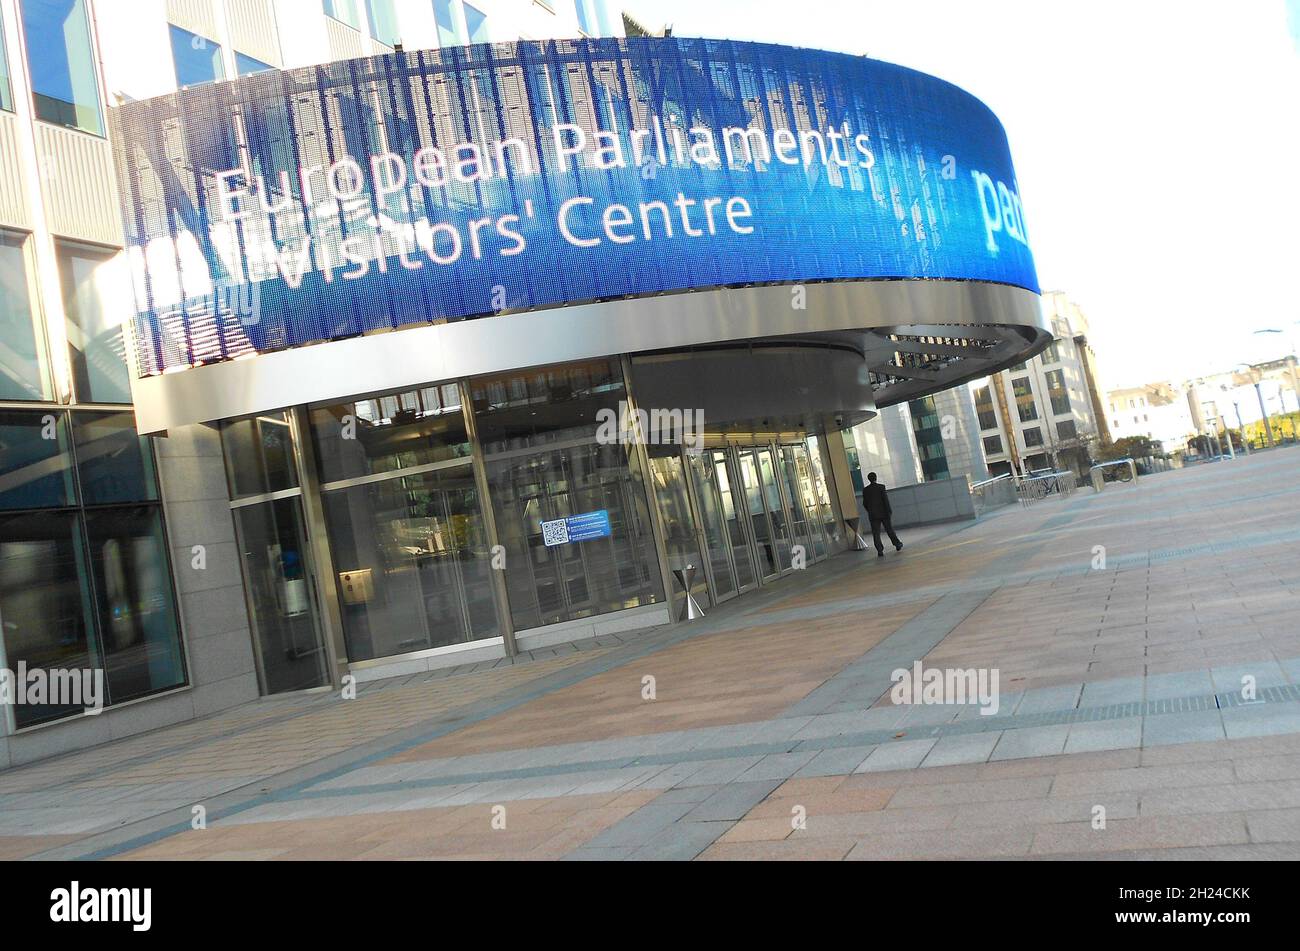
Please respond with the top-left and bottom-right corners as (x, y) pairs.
(204, 350), (839, 692)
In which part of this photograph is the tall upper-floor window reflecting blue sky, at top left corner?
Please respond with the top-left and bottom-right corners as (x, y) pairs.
(18, 0), (104, 135)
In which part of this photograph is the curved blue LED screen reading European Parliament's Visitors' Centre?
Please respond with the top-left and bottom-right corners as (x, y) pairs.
(113, 39), (1037, 375)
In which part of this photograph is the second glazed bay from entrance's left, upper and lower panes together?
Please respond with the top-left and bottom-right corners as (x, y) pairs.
(311, 383), (501, 660)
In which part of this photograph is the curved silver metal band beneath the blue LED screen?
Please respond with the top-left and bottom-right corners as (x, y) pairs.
(131, 279), (1048, 433)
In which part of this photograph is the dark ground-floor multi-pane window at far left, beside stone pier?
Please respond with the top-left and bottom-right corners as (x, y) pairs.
(0, 409), (186, 728)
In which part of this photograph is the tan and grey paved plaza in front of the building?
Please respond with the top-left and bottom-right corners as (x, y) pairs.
(0, 448), (1300, 860)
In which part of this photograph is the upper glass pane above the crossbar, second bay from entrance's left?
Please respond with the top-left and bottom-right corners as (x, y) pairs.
(311, 383), (469, 485)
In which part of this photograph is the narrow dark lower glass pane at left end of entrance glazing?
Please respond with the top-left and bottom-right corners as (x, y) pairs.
(234, 499), (329, 694)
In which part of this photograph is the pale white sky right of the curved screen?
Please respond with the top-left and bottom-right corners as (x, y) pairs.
(624, 0), (1300, 388)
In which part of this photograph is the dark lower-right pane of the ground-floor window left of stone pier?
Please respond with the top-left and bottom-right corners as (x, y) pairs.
(85, 505), (185, 703)
